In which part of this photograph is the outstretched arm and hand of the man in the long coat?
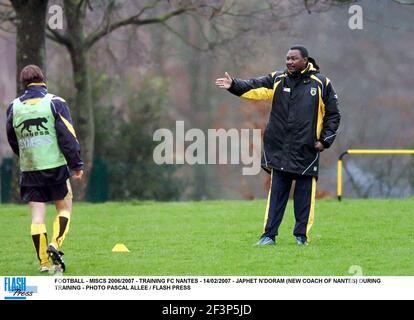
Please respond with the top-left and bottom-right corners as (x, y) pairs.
(216, 72), (276, 100)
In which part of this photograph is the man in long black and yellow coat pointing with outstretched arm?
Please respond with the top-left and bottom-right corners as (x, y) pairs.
(216, 46), (340, 245)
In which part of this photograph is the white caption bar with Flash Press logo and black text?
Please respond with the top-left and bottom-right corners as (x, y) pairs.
(0, 276), (414, 300)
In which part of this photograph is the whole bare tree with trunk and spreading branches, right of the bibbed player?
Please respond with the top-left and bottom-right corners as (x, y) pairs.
(47, 0), (205, 199)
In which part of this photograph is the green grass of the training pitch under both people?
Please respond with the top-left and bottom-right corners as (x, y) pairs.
(0, 199), (414, 276)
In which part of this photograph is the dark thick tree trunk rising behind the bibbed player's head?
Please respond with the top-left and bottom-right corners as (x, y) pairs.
(11, 0), (48, 95)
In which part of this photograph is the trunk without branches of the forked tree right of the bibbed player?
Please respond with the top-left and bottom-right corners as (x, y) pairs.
(65, 0), (95, 200)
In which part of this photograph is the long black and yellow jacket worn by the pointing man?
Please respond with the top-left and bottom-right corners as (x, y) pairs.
(229, 62), (341, 176)
